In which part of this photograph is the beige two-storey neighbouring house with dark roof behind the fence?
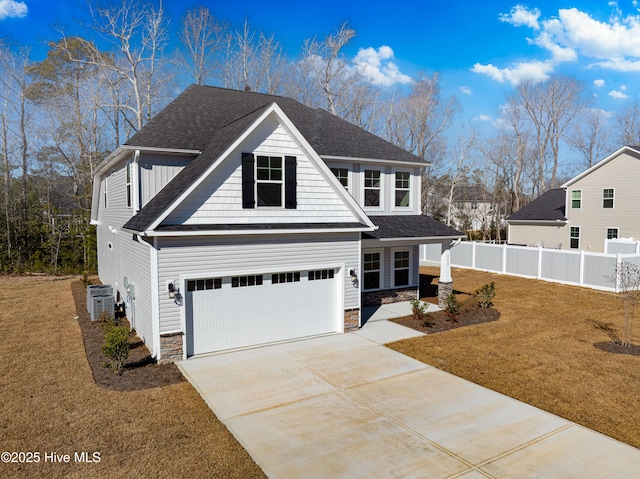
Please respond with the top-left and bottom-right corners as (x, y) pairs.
(507, 146), (640, 252)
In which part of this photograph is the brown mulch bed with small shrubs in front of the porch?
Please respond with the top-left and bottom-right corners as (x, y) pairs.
(391, 295), (500, 334)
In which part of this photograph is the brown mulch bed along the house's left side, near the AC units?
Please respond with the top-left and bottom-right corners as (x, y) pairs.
(71, 280), (185, 391)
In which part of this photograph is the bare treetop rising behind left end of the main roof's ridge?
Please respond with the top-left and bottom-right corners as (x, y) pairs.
(179, 6), (228, 85)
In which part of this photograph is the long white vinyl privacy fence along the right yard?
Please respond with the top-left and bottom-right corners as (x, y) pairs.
(420, 241), (640, 292)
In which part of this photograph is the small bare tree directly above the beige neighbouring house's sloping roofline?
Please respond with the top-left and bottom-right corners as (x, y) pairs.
(567, 108), (612, 169)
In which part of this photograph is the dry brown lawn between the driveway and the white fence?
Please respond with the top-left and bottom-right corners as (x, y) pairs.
(390, 268), (640, 447)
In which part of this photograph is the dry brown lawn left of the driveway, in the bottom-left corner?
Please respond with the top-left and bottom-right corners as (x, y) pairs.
(0, 277), (265, 478)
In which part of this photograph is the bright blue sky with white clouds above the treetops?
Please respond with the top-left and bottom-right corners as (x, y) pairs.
(0, 0), (640, 142)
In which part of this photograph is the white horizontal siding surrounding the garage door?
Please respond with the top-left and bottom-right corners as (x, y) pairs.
(158, 233), (360, 333)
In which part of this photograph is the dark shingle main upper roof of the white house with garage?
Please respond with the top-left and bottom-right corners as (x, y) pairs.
(124, 85), (426, 231)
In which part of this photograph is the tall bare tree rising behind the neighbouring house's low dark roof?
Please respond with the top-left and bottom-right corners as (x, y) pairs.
(510, 75), (587, 194)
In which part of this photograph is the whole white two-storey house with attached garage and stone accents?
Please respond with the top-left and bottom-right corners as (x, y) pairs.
(92, 85), (462, 360)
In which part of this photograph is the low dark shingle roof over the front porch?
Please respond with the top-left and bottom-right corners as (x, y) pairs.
(362, 215), (464, 239)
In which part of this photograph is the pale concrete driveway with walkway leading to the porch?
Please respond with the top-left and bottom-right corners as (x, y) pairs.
(179, 320), (640, 479)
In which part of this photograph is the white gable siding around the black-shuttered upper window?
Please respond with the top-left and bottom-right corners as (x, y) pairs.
(163, 119), (359, 225)
